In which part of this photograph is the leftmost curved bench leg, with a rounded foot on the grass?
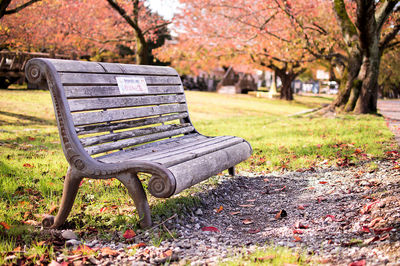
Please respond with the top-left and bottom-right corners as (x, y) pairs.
(42, 167), (82, 228)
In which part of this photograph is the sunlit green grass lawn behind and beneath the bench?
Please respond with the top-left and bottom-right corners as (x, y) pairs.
(0, 90), (394, 264)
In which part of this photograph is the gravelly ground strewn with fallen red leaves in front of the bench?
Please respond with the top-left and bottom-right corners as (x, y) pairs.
(0, 156), (400, 266)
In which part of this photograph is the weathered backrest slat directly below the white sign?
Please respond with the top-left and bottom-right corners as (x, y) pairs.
(68, 95), (185, 112)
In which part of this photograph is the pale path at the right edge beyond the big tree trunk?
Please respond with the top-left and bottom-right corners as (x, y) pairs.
(378, 100), (400, 145)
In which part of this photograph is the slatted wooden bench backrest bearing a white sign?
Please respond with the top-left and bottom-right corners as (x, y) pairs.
(31, 59), (195, 155)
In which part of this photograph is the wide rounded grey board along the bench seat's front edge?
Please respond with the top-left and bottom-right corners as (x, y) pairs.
(168, 142), (251, 194)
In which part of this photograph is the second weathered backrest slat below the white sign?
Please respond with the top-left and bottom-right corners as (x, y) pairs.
(72, 104), (187, 126)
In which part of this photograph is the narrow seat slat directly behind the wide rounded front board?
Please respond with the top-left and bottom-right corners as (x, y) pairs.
(151, 138), (243, 167)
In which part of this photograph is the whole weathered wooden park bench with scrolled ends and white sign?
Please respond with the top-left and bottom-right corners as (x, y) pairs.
(25, 58), (252, 228)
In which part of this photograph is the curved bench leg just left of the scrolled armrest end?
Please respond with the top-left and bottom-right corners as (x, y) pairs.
(117, 173), (151, 228)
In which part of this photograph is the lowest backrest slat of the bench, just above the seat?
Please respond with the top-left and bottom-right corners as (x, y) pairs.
(85, 126), (194, 155)
